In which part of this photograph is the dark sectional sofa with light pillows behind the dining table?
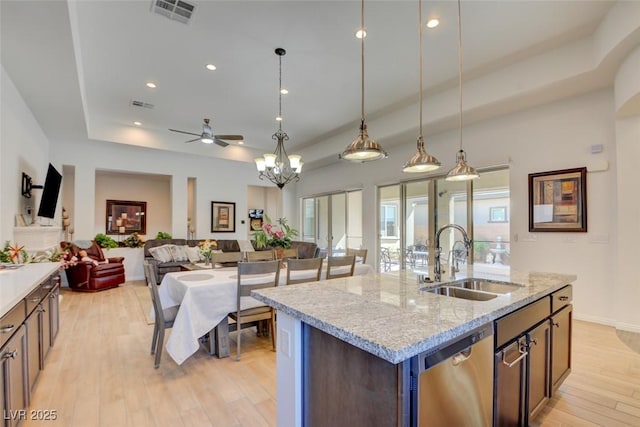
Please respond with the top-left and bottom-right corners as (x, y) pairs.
(144, 239), (318, 284)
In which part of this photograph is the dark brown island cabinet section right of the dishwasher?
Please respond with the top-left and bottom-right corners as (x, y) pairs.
(494, 285), (572, 426)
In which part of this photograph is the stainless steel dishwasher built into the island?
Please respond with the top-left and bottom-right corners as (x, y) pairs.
(411, 324), (493, 427)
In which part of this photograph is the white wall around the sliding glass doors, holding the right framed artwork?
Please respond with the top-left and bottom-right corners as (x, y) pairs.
(298, 90), (620, 325)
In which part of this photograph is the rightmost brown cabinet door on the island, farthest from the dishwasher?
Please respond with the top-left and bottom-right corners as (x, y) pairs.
(551, 305), (573, 392)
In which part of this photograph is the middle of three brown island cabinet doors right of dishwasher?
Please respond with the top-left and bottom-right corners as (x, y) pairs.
(527, 320), (550, 421)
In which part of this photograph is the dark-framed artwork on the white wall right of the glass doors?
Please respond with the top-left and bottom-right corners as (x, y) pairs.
(529, 167), (587, 232)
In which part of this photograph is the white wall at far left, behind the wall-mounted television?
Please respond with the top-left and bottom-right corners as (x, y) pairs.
(0, 67), (52, 245)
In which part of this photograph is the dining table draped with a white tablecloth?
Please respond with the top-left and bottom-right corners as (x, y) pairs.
(158, 260), (374, 365)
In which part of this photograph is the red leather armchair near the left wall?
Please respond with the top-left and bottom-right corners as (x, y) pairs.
(61, 241), (125, 292)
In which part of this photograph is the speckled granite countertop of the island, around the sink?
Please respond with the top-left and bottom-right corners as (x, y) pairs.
(252, 268), (577, 363)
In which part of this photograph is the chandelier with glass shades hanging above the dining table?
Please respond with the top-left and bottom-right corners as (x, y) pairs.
(254, 47), (304, 190)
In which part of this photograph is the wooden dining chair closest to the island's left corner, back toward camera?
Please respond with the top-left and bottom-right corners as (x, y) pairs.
(229, 260), (280, 360)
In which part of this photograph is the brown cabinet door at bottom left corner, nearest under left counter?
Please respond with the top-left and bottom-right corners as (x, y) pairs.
(0, 325), (28, 427)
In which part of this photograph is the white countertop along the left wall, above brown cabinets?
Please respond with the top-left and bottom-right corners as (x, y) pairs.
(0, 262), (60, 317)
